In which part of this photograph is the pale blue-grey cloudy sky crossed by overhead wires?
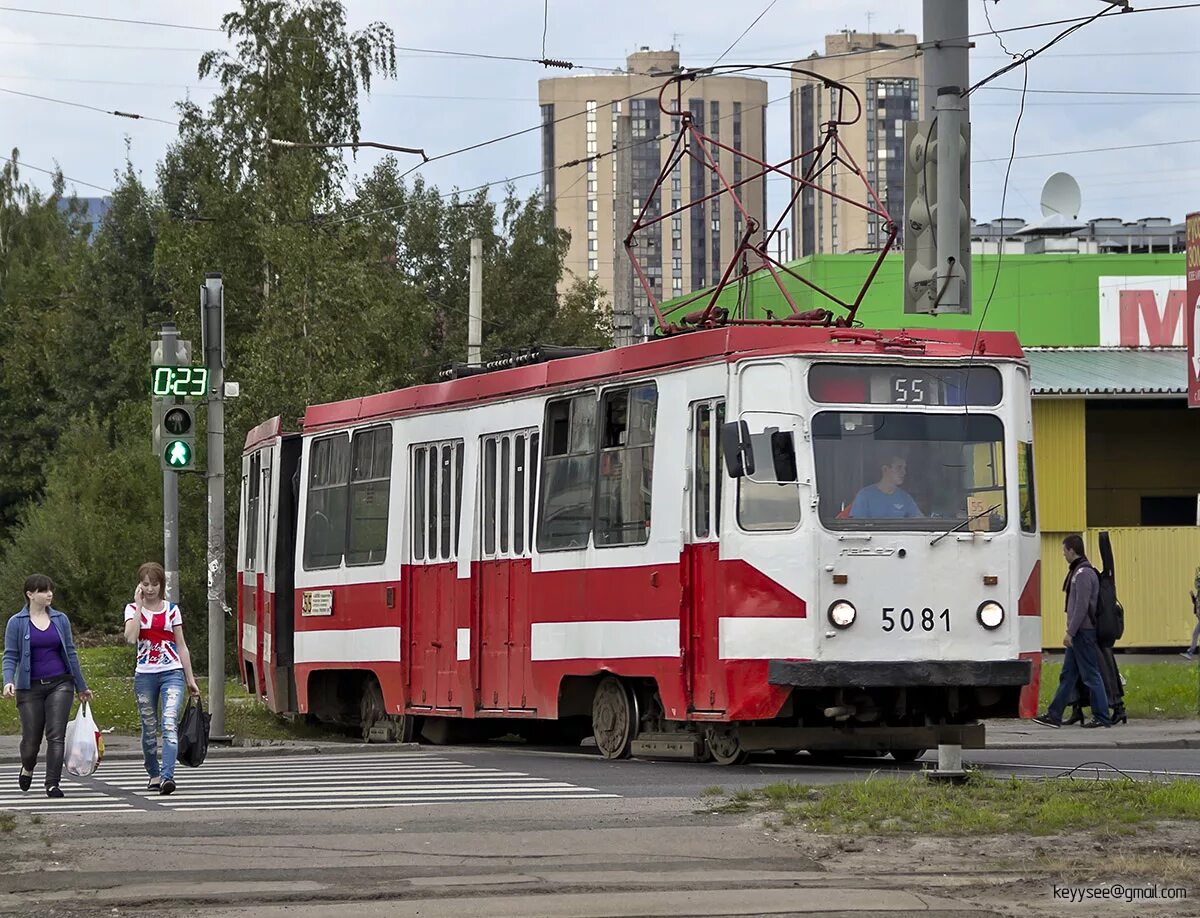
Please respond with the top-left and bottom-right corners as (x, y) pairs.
(0, 0), (1200, 228)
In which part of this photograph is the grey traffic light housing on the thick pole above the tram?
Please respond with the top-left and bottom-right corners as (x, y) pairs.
(902, 120), (971, 313)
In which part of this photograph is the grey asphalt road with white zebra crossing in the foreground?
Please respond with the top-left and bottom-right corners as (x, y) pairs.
(0, 745), (1200, 918)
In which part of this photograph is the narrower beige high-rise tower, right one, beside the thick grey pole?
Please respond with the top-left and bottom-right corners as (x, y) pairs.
(791, 30), (922, 257)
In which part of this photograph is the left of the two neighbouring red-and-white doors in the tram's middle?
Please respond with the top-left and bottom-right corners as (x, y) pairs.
(406, 440), (463, 709)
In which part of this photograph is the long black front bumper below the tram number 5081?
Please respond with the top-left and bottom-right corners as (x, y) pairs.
(767, 660), (1033, 689)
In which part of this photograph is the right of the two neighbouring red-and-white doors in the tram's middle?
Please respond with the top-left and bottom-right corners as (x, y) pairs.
(472, 428), (538, 709)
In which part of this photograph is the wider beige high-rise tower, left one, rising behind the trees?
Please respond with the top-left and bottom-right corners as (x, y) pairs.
(538, 48), (767, 343)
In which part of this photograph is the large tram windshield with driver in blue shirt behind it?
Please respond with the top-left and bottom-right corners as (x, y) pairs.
(812, 412), (1007, 532)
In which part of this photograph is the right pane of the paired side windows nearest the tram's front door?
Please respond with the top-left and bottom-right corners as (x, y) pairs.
(595, 385), (659, 547)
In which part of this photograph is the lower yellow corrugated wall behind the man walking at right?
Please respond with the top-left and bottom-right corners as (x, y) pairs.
(1034, 525), (1200, 648)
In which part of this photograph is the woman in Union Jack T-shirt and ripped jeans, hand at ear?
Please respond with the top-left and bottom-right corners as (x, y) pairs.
(125, 562), (200, 796)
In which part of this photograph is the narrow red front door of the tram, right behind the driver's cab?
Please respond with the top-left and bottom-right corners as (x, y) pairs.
(686, 398), (728, 712)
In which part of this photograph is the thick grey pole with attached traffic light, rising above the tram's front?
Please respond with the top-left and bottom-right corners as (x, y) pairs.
(905, 0), (971, 314)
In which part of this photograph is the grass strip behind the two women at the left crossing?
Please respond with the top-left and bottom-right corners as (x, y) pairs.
(0, 646), (328, 739)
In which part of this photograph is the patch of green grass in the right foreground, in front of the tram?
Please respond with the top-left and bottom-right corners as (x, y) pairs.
(715, 772), (1200, 835)
